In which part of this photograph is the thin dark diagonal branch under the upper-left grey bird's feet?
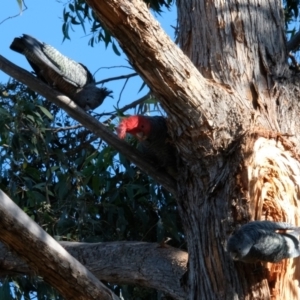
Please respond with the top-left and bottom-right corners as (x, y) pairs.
(0, 55), (176, 195)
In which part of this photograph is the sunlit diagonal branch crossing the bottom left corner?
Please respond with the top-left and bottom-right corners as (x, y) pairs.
(0, 190), (119, 300)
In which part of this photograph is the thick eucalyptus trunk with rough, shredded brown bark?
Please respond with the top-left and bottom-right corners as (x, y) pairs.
(177, 0), (300, 299)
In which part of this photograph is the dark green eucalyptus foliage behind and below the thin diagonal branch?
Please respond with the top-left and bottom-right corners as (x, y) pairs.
(0, 80), (183, 299)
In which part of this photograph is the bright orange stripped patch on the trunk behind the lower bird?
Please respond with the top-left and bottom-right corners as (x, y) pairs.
(231, 131), (300, 299)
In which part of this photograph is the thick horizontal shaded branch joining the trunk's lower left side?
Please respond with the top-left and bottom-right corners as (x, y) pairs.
(0, 242), (188, 299)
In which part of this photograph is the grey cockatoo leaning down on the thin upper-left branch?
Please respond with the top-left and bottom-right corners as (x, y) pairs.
(10, 34), (111, 110)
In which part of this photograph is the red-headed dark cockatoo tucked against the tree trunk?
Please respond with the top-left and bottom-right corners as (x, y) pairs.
(117, 115), (177, 178)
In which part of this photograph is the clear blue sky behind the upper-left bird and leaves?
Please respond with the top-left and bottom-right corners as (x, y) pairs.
(0, 0), (176, 112)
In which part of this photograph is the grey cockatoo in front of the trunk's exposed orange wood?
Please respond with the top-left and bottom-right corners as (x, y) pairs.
(227, 221), (300, 263)
